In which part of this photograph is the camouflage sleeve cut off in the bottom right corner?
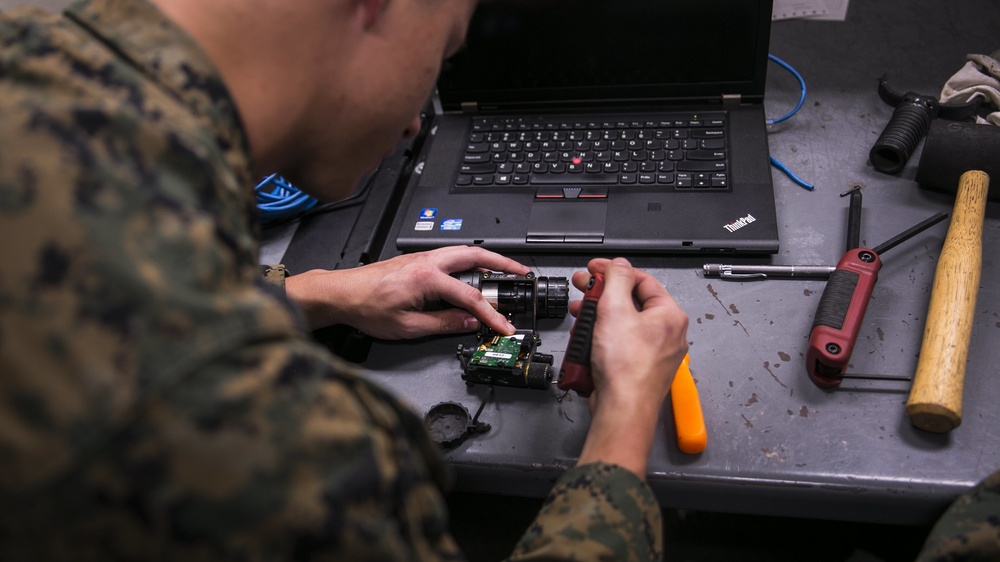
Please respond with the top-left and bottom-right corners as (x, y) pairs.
(917, 471), (1000, 562)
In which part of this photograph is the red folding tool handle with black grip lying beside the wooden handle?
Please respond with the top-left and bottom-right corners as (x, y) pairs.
(806, 248), (882, 388)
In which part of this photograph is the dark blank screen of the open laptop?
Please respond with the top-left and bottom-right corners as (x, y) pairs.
(438, 0), (771, 110)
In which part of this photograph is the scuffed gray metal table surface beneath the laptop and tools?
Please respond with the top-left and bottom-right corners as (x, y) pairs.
(268, 0), (1000, 524)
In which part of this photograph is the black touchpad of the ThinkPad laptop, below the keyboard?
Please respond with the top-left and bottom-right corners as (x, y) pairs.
(527, 199), (608, 244)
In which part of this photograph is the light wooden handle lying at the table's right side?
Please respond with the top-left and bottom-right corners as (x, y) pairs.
(906, 170), (990, 433)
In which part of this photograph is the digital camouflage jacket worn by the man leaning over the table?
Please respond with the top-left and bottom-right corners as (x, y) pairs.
(0, 0), (662, 561)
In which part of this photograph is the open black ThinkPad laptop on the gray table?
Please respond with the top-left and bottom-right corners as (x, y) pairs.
(396, 0), (778, 253)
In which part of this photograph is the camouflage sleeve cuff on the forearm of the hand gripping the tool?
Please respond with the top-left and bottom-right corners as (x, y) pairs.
(510, 463), (663, 562)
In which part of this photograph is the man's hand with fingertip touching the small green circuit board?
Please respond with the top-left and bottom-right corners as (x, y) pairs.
(285, 246), (531, 339)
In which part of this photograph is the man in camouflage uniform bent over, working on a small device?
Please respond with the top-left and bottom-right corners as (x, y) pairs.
(0, 0), (687, 560)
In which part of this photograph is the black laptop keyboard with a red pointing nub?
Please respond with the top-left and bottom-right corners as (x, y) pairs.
(455, 112), (729, 191)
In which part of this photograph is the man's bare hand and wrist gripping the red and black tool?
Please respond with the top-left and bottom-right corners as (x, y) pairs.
(570, 258), (688, 477)
